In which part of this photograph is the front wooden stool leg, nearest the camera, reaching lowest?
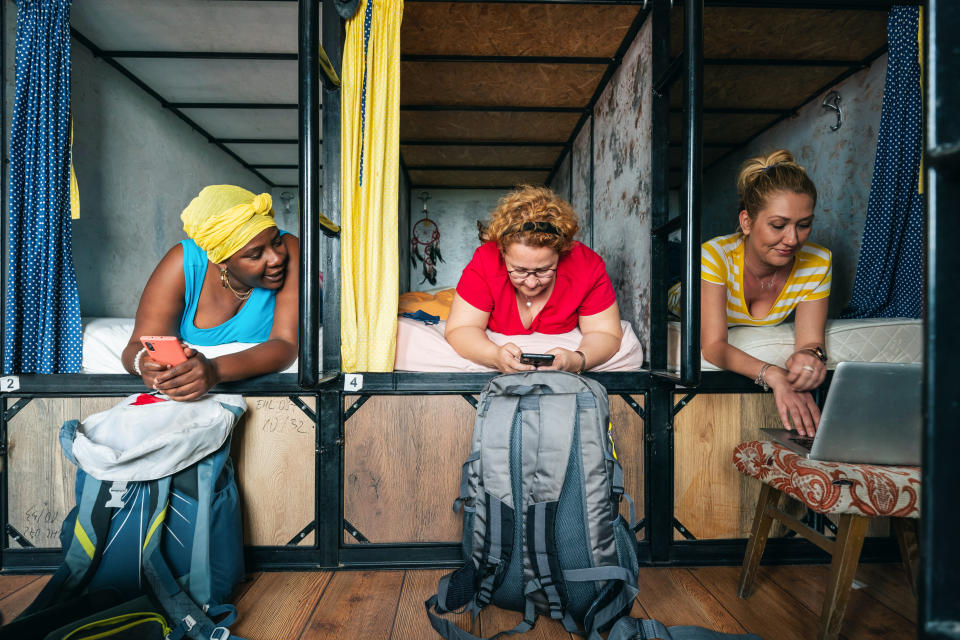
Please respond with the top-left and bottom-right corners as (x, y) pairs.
(817, 513), (869, 640)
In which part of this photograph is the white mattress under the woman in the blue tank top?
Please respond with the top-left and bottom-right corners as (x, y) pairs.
(80, 318), (297, 373)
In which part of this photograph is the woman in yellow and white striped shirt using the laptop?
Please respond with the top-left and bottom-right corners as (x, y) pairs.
(700, 149), (831, 435)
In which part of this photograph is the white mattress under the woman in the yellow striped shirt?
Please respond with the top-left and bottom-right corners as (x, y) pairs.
(667, 318), (923, 371)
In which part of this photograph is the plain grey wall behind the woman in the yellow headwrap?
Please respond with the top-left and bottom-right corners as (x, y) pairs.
(72, 33), (272, 317)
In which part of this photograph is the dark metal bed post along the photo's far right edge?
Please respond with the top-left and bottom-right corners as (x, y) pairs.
(919, 0), (960, 640)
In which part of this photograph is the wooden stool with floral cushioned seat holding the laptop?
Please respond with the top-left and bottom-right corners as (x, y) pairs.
(733, 441), (920, 640)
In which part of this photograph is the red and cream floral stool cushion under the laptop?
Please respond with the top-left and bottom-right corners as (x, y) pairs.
(733, 441), (920, 518)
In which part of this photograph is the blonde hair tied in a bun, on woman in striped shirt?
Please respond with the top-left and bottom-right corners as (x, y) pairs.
(737, 149), (817, 220)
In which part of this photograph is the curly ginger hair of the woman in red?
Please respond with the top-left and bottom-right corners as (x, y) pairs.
(480, 185), (580, 255)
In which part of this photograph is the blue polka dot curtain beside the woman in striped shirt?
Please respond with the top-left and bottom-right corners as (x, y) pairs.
(842, 7), (924, 318)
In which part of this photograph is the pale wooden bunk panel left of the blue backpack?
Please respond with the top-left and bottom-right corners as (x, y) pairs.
(6, 398), (79, 548)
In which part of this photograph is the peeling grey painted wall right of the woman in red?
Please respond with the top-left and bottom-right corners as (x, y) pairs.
(554, 21), (652, 349)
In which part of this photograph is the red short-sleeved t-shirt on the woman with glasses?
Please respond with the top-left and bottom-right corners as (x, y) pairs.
(457, 242), (617, 336)
